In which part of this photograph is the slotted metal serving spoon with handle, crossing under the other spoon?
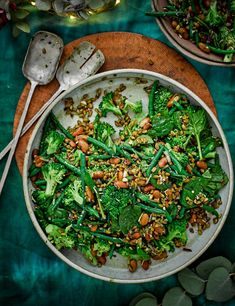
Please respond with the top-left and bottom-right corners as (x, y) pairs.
(0, 41), (105, 160)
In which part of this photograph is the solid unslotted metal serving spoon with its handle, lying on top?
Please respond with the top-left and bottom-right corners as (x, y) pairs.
(0, 31), (63, 194)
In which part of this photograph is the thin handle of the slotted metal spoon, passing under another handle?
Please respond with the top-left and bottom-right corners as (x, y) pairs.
(0, 86), (65, 160)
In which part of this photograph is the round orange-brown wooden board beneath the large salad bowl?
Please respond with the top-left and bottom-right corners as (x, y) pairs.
(14, 32), (216, 174)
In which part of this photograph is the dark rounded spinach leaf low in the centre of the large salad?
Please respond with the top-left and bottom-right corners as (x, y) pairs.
(119, 205), (141, 234)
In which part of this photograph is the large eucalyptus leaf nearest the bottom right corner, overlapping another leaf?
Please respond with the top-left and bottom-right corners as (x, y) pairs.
(206, 267), (235, 302)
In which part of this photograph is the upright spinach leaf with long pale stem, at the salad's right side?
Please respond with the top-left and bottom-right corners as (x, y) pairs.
(188, 109), (207, 159)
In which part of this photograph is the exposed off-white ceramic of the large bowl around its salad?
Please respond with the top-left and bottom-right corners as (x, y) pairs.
(23, 69), (233, 283)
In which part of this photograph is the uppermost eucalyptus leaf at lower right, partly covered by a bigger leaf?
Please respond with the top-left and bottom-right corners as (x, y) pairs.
(196, 256), (232, 279)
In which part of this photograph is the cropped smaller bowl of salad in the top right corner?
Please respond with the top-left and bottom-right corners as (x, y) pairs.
(146, 0), (235, 67)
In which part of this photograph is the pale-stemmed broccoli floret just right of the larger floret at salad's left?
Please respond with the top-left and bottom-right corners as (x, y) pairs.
(64, 179), (83, 206)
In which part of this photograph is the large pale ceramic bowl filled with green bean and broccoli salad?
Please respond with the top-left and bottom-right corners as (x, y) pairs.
(23, 69), (233, 283)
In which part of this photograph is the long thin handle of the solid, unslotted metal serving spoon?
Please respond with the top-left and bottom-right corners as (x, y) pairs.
(0, 81), (38, 195)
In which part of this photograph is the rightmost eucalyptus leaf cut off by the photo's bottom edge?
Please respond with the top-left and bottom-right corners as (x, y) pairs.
(162, 287), (193, 306)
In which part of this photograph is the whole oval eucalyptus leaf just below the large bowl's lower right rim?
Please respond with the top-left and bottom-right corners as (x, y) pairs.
(178, 268), (205, 296)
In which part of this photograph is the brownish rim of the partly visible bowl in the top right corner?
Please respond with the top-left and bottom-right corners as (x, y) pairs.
(151, 0), (235, 67)
